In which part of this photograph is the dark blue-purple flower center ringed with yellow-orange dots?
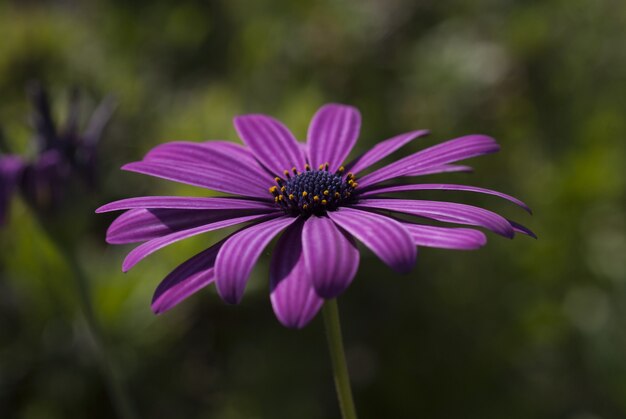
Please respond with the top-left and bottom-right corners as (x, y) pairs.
(269, 163), (358, 215)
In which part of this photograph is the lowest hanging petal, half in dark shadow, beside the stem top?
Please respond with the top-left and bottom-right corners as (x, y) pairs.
(270, 220), (324, 329)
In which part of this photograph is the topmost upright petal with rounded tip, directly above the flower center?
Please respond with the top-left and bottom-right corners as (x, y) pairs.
(307, 103), (361, 172)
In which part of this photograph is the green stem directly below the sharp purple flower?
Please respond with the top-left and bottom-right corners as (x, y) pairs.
(322, 300), (356, 419)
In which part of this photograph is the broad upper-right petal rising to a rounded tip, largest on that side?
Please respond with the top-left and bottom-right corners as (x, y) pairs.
(359, 135), (500, 187)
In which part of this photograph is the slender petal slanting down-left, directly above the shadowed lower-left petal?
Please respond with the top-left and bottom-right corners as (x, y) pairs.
(122, 212), (282, 272)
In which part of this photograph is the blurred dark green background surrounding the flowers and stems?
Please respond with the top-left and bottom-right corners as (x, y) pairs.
(0, 0), (626, 419)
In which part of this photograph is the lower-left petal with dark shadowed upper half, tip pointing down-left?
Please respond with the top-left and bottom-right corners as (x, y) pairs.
(152, 241), (224, 314)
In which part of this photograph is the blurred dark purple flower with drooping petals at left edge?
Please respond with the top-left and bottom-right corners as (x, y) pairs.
(0, 83), (115, 224)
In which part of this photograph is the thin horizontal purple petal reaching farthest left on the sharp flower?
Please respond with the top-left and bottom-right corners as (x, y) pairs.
(96, 196), (276, 213)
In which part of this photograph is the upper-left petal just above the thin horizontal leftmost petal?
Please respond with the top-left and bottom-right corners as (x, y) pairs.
(122, 160), (270, 199)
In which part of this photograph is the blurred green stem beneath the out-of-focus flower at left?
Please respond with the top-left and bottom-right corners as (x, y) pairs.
(39, 219), (137, 419)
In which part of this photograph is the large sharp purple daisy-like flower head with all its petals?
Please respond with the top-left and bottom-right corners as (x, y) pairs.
(97, 104), (533, 328)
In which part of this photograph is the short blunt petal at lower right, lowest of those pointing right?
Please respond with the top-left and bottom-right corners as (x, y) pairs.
(403, 223), (487, 250)
